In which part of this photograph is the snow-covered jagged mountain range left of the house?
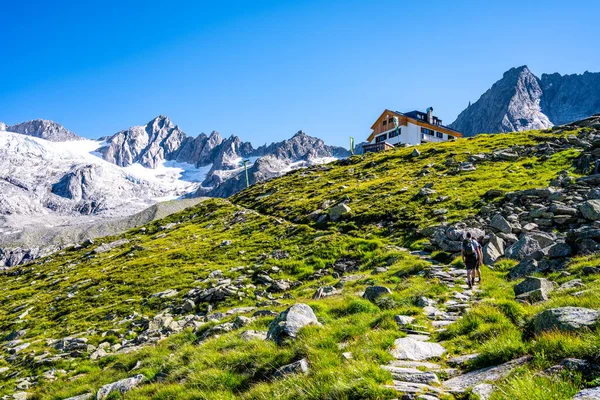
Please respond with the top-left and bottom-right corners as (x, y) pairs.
(0, 116), (349, 267)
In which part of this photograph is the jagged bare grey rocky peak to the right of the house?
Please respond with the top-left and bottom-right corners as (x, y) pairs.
(450, 66), (600, 136)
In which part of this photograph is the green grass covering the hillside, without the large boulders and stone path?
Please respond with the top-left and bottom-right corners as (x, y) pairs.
(0, 126), (600, 399)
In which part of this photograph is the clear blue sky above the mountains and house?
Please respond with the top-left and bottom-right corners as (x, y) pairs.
(0, 0), (600, 145)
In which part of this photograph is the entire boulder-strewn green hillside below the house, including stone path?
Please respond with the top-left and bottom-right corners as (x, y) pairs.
(0, 117), (600, 400)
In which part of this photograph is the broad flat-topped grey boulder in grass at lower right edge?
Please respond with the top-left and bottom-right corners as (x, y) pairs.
(533, 307), (600, 334)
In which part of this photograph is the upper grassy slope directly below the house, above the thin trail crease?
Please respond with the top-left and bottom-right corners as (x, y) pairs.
(232, 131), (579, 236)
